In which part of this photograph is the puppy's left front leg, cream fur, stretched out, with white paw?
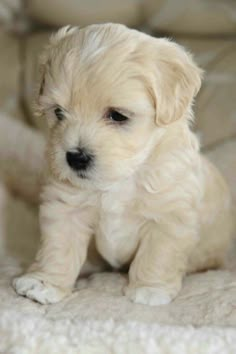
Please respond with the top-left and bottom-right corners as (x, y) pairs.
(13, 185), (92, 304)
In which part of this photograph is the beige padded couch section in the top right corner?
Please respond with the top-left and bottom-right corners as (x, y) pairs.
(148, 0), (236, 35)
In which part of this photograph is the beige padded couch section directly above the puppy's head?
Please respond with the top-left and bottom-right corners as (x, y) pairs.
(28, 0), (141, 26)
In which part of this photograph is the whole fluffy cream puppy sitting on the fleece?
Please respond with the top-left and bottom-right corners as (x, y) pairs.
(13, 24), (231, 305)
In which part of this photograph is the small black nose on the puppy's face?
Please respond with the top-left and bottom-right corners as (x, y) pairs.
(66, 149), (93, 171)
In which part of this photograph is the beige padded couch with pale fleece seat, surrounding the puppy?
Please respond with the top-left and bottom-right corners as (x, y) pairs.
(0, 0), (236, 354)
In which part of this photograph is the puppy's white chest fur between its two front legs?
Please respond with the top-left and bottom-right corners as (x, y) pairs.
(95, 184), (142, 268)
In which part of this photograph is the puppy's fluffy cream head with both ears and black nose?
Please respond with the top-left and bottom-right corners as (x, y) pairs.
(37, 24), (201, 186)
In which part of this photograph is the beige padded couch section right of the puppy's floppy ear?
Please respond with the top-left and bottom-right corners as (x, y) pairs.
(178, 39), (236, 146)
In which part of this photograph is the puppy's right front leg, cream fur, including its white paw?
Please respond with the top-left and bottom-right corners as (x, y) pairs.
(125, 223), (196, 306)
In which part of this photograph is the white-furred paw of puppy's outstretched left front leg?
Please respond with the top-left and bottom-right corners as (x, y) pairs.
(12, 273), (69, 305)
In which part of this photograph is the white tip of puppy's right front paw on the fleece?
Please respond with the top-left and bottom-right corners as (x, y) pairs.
(125, 286), (175, 306)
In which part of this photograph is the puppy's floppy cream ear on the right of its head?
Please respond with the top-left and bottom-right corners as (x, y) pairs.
(149, 39), (202, 126)
